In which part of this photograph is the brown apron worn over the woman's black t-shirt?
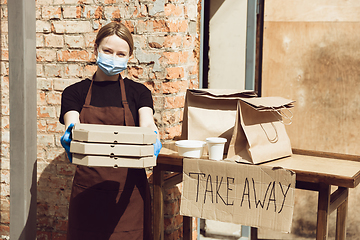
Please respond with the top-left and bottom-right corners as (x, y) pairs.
(67, 77), (152, 240)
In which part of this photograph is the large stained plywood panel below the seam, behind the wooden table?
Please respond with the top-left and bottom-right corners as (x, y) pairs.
(262, 22), (360, 156)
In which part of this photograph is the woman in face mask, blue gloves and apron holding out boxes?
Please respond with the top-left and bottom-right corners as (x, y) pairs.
(60, 22), (161, 240)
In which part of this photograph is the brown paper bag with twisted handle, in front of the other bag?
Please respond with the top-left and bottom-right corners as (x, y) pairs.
(227, 97), (294, 164)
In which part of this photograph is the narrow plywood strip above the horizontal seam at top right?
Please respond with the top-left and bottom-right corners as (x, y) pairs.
(265, 0), (360, 22)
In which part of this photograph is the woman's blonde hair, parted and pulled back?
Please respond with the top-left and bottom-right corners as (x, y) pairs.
(95, 22), (134, 56)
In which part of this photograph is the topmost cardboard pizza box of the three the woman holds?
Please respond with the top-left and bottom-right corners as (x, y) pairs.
(72, 123), (156, 144)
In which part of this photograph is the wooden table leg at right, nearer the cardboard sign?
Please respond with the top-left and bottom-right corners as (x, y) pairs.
(316, 183), (331, 240)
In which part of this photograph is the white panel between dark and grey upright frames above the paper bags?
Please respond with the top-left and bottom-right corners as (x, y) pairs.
(208, 0), (247, 89)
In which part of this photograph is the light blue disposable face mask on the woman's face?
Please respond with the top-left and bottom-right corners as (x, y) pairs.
(96, 52), (129, 76)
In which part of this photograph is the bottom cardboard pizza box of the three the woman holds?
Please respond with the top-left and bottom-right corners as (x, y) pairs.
(72, 153), (156, 168)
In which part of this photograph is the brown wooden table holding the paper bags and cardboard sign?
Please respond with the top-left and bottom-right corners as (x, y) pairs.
(153, 148), (360, 240)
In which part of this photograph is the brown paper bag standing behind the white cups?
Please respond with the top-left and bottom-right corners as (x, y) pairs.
(181, 89), (256, 154)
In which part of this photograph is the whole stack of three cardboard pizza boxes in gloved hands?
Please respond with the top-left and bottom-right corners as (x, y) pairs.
(70, 124), (156, 168)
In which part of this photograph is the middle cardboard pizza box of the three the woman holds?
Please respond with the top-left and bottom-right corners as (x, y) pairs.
(70, 141), (154, 157)
